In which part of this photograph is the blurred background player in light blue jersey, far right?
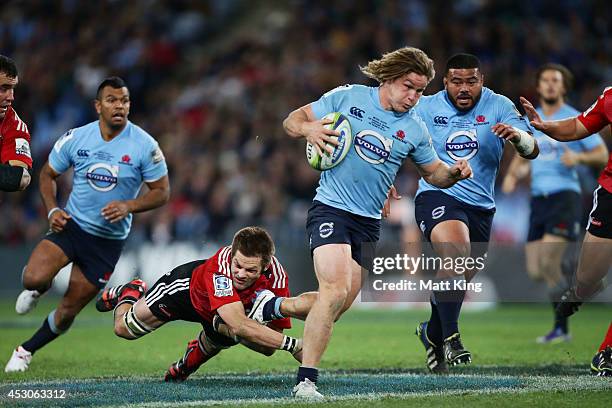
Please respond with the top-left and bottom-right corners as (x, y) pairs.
(502, 64), (608, 344)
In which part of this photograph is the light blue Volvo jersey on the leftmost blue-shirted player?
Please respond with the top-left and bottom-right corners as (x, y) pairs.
(49, 121), (168, 239)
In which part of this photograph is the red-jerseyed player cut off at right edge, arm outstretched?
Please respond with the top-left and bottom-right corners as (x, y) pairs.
(521, 87), (612, 376)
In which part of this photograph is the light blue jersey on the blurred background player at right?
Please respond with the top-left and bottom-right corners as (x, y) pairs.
(530, 104), (604, 196)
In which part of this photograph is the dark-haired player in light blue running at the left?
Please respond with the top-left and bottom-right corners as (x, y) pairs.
(5, 77), (170, 372)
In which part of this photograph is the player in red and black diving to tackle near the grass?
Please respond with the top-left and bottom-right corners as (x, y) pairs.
(96, 227), (302, 381)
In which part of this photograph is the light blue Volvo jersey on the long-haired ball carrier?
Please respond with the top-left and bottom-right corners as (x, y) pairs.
(311, 85), (437, 219)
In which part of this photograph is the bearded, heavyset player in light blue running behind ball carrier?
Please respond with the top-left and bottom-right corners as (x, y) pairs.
(415, 54), (538, 373)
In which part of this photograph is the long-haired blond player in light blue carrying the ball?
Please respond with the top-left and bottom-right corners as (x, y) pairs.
(283, 47), (471, 398)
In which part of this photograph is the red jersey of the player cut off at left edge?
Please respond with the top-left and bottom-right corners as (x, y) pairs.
(0, 107), (32, 167)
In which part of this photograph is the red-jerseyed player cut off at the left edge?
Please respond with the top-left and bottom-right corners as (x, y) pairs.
(0, 55), (32, 191)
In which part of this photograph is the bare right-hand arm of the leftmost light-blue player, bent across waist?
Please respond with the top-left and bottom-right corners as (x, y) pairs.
(102, 176), (170, 223)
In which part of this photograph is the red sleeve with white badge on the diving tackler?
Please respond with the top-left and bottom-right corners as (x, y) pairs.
(204, 247), (241, 313)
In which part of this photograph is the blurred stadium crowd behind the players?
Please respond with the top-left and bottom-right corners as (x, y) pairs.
(0, 0), (612, 244)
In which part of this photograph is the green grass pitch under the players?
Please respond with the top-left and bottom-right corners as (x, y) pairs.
(0, 300), (612, 408)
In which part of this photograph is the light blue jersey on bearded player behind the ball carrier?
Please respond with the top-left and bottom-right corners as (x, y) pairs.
(414, 87), (532, 209)
